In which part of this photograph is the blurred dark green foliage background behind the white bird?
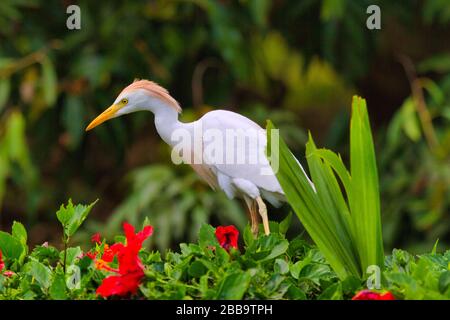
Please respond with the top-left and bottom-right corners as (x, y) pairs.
(0, 0), (450, 252)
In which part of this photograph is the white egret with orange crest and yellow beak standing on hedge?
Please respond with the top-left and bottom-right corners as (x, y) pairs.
(86, 80), (312, 234)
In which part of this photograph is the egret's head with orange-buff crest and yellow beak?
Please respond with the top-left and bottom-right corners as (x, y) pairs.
(86, 80), (181, 131)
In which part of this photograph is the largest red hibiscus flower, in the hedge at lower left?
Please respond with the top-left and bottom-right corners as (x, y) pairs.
(96, 223), (153, 298)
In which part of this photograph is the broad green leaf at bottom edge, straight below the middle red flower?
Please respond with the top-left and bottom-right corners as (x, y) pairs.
(216, 272), (251, 300)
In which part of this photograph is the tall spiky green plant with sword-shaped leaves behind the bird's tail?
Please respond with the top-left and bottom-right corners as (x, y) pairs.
(267, 96), (384, 279)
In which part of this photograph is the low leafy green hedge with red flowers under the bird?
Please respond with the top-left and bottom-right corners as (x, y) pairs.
(0, 203), (450, 300)
